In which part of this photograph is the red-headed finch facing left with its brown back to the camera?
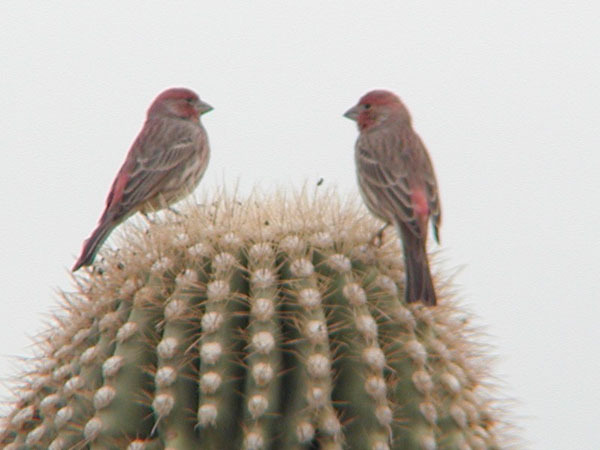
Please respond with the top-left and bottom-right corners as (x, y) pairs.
(344, 90), (441, 306)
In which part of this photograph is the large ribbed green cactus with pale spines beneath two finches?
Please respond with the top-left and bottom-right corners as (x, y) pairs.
(0, 193), (508, 450)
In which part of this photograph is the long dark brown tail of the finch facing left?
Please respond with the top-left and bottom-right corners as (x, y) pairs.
(399, 224), (437, 306)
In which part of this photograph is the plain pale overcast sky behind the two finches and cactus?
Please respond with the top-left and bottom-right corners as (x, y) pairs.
(0, 0), (600, 450)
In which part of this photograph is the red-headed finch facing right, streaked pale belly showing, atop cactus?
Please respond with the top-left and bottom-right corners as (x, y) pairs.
(73, 88), (212, 271)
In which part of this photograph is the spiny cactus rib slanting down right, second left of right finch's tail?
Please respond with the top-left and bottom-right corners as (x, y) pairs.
(316, 245), (392, 449)
